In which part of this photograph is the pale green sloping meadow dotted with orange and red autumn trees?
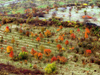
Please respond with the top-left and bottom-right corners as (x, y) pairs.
(0, 23), (99, 75)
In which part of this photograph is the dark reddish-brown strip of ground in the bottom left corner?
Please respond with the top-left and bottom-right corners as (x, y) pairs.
(0, 63), (44, 75)
